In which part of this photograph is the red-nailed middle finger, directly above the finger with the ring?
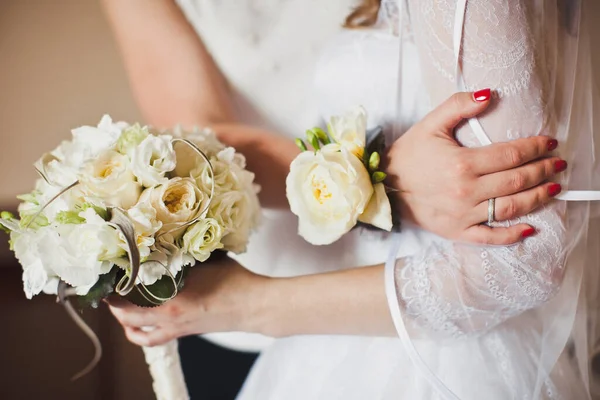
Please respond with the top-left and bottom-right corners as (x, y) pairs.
(477, 157), (568, 199)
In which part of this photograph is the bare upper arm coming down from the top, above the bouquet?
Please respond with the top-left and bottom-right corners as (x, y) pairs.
(102, 0), (234, 128)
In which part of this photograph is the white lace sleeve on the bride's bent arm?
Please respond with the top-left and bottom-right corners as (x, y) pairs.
(395, 0), (575, 336)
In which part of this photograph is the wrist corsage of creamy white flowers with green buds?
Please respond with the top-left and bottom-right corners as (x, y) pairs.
(286, 107), (393, 245)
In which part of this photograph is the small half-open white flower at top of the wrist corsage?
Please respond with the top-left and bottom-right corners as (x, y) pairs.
(329, 107), (367, 158)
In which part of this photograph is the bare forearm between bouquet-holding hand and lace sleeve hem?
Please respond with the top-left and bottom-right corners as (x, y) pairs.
(248, 265), (396, 337)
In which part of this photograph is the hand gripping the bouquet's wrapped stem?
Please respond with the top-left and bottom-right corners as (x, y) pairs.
(107, 258), (269, 346)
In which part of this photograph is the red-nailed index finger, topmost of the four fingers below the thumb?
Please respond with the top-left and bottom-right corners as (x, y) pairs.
(465, 136), (558, 175)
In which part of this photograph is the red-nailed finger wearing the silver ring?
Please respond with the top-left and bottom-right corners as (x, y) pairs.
(471, 182), (562, 224)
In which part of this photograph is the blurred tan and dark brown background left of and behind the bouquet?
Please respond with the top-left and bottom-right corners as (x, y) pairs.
(0, 0), (153, 400)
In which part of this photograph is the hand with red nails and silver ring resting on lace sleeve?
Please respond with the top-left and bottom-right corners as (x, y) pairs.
(385, 90), (567, 245)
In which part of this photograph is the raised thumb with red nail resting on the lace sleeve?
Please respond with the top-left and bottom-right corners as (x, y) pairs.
(423, 89), (492, 138)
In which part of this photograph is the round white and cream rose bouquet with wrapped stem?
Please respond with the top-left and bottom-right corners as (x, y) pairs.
(0, 116), (260, 400)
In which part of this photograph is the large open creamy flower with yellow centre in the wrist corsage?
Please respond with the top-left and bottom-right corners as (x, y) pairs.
(286, 144), (373, 245)
